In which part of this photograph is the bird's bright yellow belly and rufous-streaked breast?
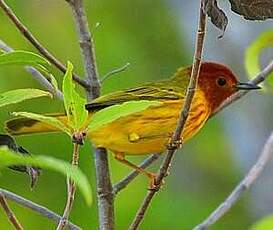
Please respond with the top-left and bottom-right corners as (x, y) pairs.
(88, 100), (209, 154)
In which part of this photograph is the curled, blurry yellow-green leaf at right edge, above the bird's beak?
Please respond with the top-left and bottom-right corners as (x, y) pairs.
(245, 30), (273, 86)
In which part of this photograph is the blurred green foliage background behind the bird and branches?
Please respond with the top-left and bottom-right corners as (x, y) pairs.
(0, 0), (270, 230)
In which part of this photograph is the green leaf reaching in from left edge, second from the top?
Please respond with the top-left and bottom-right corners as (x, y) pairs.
(0, 89), (52, 107)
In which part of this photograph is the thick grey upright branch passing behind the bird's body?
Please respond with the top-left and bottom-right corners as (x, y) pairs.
(66, 0), (115, 230)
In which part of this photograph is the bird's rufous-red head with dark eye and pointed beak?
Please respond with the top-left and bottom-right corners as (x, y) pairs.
(198, 62), (260, 112)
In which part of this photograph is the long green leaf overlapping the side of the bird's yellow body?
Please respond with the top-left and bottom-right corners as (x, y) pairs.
(88, 100), (162, 132)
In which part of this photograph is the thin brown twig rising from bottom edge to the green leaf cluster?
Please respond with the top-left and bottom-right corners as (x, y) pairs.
(57, 143), (80, 230)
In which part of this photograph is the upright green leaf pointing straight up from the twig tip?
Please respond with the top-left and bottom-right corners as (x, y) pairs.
(63, 62), (88, 130)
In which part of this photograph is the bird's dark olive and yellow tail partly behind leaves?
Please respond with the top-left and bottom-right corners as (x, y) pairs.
(5, 113), (67, 135)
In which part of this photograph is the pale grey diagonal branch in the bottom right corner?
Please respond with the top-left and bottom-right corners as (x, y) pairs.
(194, 133), (273, 230)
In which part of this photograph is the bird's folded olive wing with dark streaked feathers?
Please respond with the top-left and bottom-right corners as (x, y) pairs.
(86, 82), (184, 111)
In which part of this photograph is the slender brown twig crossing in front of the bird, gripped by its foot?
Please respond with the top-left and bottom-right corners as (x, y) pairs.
(130, 0), (206, 230)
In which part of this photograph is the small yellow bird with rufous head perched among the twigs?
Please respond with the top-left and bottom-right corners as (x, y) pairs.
(6, 62), (260, 187)
